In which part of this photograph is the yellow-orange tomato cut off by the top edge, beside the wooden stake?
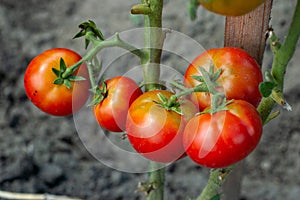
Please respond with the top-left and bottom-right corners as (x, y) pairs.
(198, 0), (266, 16)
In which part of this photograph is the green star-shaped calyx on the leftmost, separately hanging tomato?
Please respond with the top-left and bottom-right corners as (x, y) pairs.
(52, 58), (86, 89)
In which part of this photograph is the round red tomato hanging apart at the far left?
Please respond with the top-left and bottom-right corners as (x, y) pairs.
(24, 48), (90, 116)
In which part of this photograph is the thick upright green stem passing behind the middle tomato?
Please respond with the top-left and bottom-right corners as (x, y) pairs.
(142, 0), (165, 200)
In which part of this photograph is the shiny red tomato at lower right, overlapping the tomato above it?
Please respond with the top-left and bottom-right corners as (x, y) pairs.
(183, 100), (262, 168)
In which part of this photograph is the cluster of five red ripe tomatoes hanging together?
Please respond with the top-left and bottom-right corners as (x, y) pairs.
(24, 48), (262, 168)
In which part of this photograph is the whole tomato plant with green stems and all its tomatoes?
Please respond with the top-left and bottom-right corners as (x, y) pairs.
(24, 0), (300, 200)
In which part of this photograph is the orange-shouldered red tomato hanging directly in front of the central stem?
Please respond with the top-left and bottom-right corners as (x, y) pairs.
(126, 90), (197, 163)
